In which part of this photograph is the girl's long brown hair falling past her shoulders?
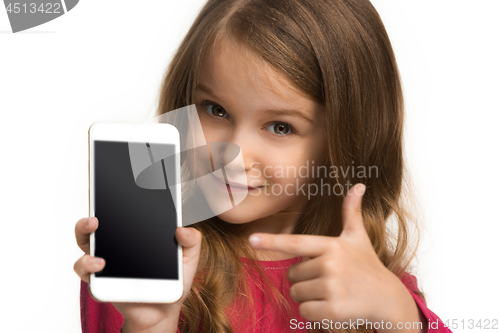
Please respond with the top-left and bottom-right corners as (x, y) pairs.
(157, 0), (418, 333)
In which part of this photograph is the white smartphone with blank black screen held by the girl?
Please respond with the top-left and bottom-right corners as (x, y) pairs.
(89, 122), (183, 303)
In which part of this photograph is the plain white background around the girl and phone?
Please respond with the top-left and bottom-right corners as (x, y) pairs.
(0, 0), (500, 333)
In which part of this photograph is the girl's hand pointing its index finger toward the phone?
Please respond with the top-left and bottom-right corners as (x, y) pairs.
(250, 184), (425, 332)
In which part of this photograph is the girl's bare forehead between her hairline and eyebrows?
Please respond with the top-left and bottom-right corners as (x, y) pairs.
(199, 39), (310, 102)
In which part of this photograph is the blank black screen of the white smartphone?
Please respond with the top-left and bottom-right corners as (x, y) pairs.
(94, 141), (179, 279)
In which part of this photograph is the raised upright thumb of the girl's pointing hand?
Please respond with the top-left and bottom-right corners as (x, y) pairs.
(341, 183), (366, 236)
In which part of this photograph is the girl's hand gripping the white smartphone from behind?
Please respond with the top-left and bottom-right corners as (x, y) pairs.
(74, 217), (201, 333)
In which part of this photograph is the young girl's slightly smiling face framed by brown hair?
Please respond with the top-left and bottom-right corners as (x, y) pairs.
(194, 38), (326, 223)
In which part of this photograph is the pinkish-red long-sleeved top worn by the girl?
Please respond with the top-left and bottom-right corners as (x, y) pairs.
(80, 257), (451, 333)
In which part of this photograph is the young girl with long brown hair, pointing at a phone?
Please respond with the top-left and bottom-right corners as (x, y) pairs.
(75, 0), (449, 333)
